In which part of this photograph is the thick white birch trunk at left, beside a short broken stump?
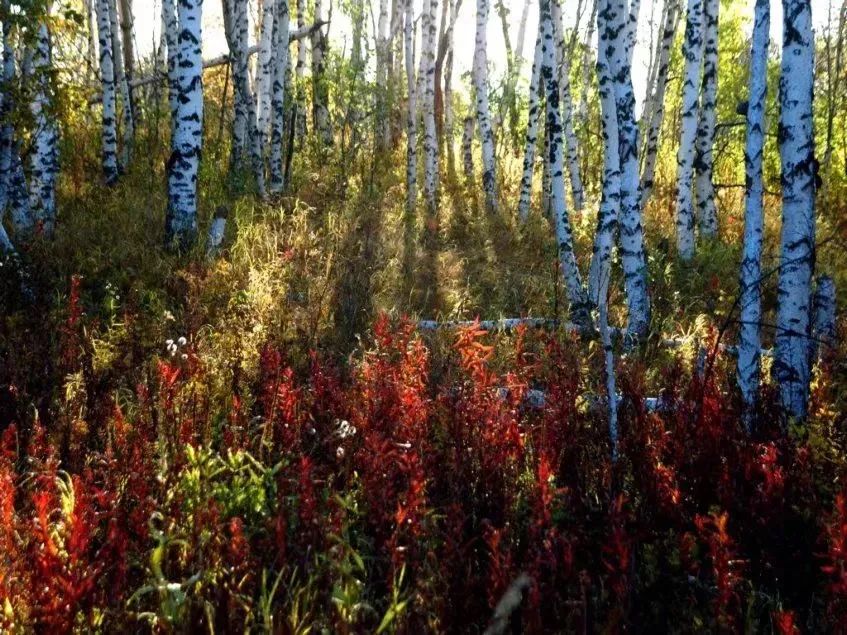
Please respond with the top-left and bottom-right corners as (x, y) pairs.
(165, 0), (203, 250)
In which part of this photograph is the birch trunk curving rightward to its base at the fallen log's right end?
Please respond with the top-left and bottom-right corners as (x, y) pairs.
(539, 0), (591, 326)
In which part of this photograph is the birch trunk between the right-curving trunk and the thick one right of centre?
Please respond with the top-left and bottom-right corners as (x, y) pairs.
(588, 0), (621, 307)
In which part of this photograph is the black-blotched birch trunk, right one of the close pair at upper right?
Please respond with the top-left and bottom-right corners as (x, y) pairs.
(694, 0), (720, 238)
